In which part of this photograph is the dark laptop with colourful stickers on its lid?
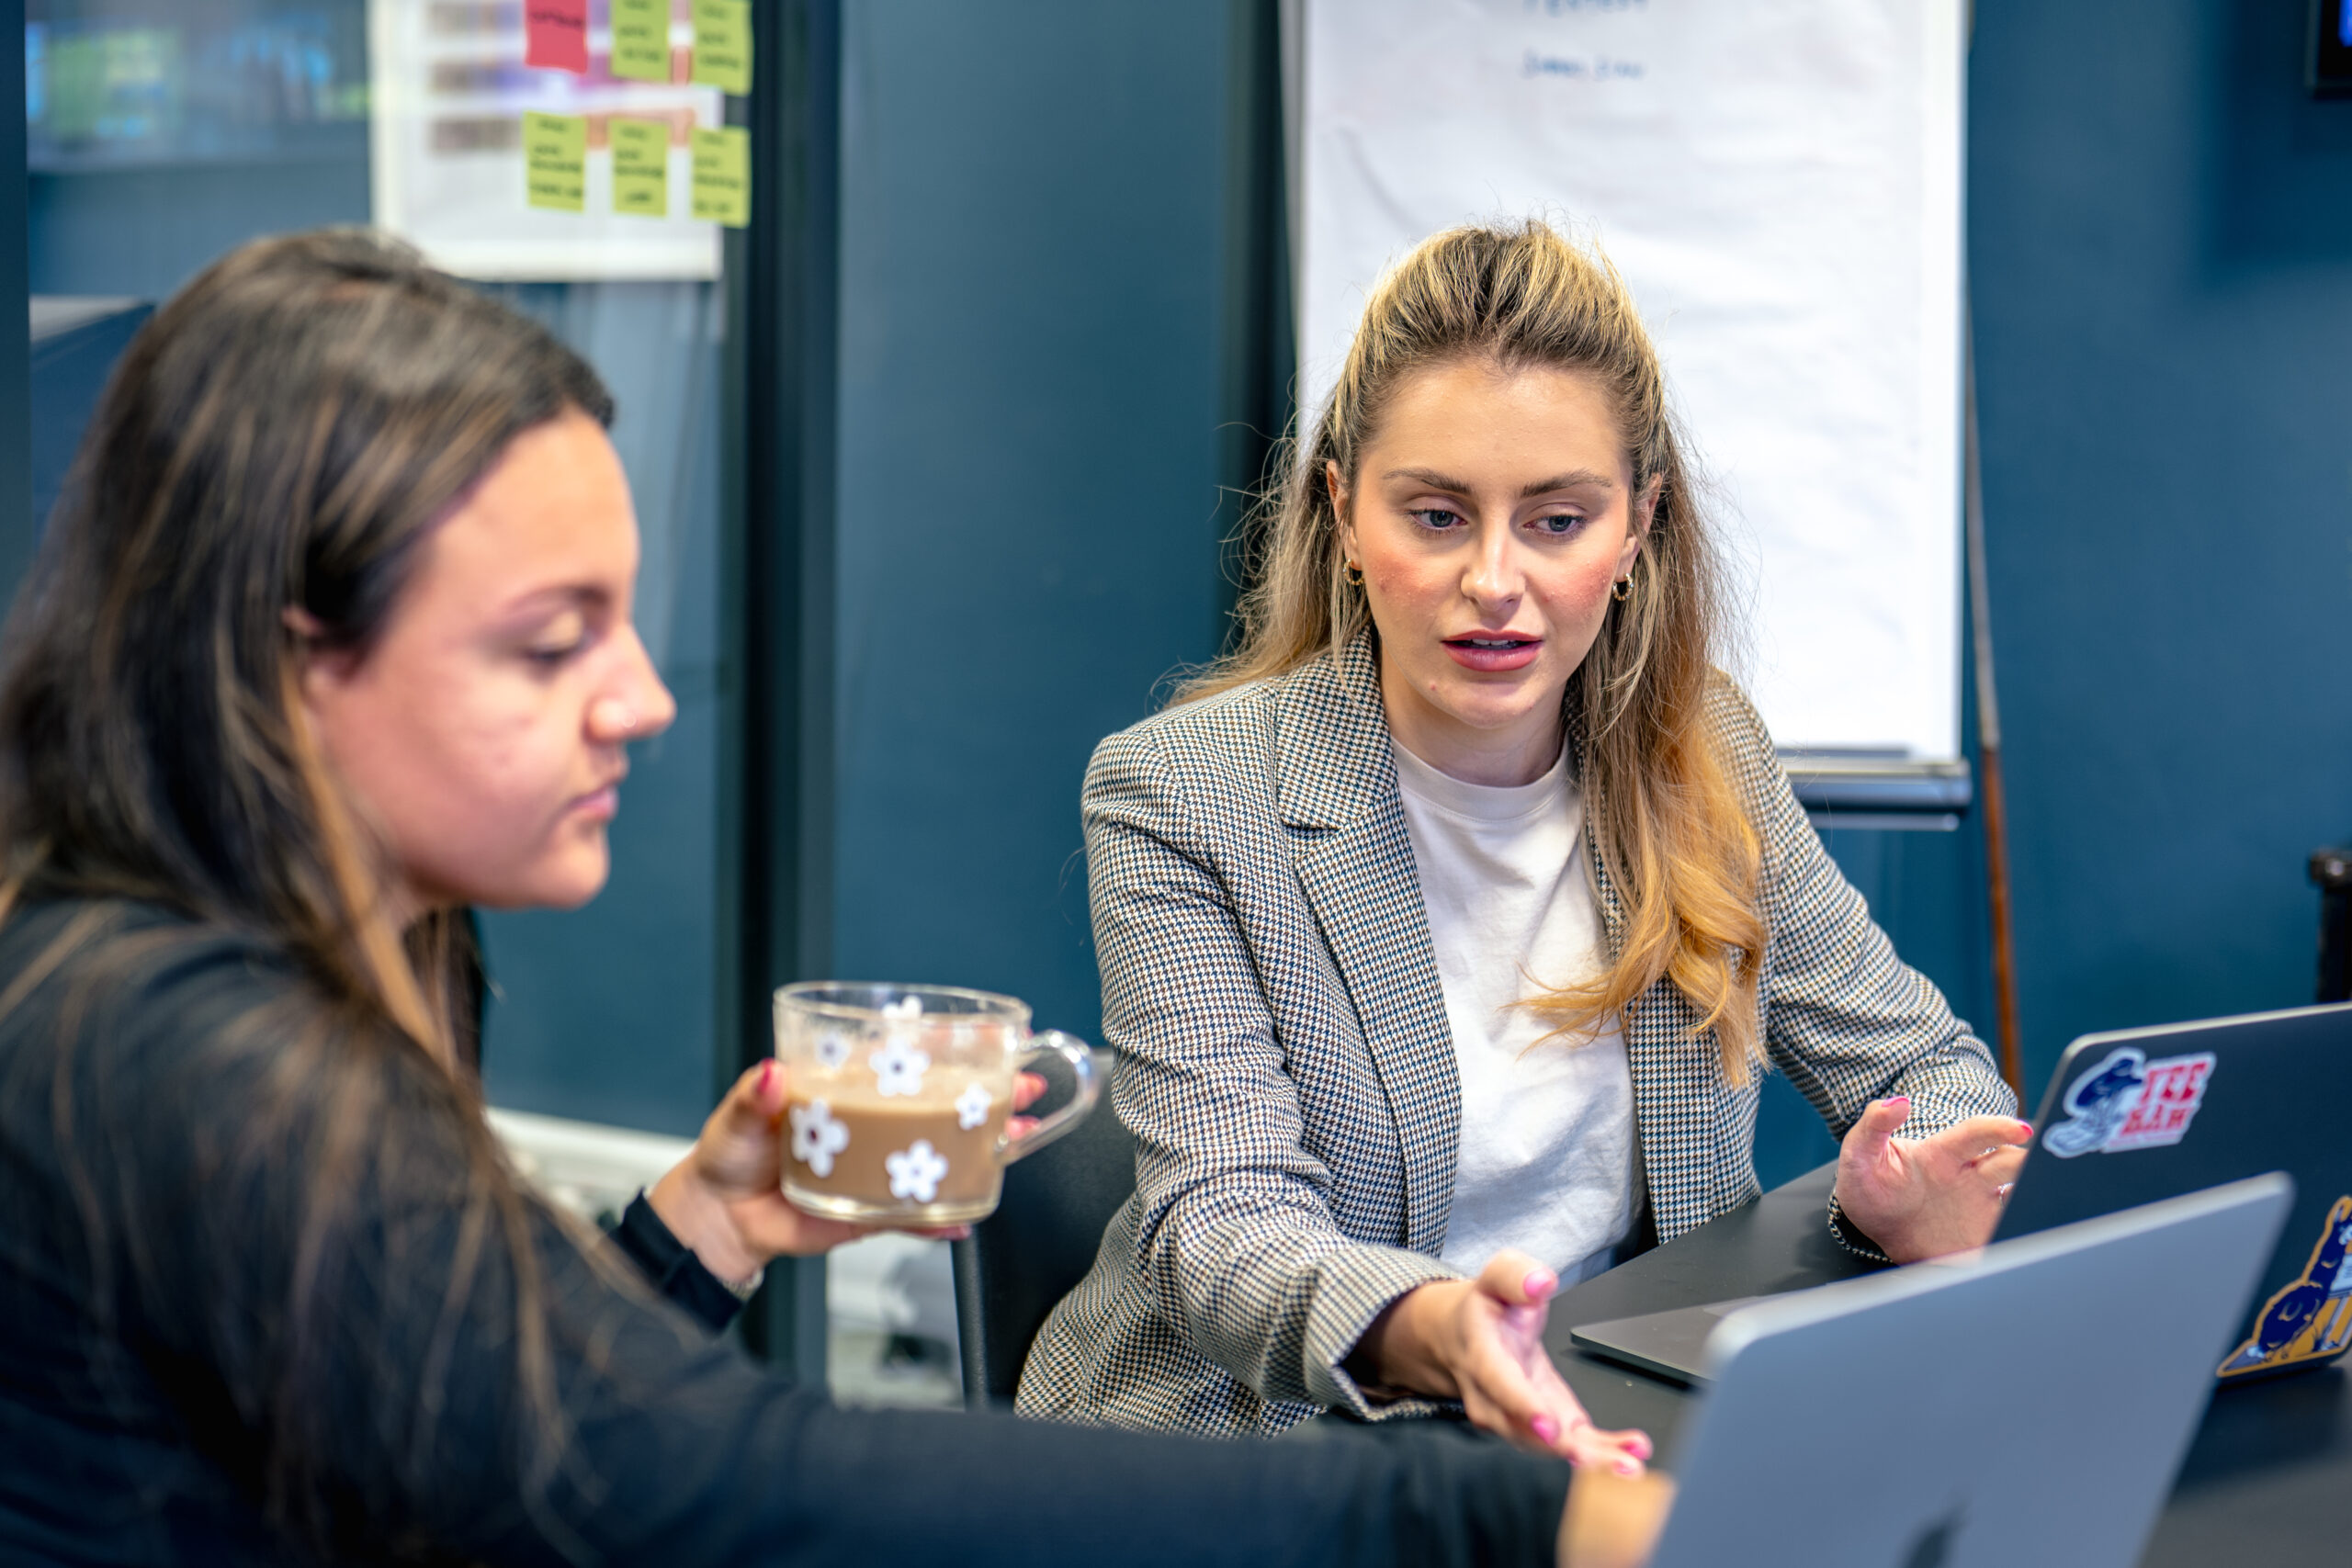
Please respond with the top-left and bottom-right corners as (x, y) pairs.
(1992, 1004), (2352, 1382)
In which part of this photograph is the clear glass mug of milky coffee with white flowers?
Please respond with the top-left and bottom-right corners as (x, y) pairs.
(776, 980), (1101, 1224)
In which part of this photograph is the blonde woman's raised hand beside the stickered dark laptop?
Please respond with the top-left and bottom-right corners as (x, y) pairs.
(1837, 1096), (2034, 1262)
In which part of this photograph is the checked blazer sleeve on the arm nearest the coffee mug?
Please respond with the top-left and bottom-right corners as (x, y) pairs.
(1084, 731), (1458, 1420)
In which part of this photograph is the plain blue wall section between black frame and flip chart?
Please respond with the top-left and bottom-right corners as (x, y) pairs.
(832, 0), (1270, 1048)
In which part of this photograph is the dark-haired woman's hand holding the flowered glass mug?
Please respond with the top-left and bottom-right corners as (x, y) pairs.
(644, 1060), (1045, 1281)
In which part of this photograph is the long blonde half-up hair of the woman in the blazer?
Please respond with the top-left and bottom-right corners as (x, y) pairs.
(1194, 221), (1764, 1084)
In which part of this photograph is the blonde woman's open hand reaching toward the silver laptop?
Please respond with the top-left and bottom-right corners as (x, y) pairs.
(1357, 1248), (1649, 1476)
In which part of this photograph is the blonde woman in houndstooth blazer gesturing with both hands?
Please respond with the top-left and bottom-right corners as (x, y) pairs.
(1018, 221), (2030, 1472)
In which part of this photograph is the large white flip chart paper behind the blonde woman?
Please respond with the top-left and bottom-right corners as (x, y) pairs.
(1298, 0), (1962, 760)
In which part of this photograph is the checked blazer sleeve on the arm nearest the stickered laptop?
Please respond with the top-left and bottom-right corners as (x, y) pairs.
(1717, 682), (2018, 1258)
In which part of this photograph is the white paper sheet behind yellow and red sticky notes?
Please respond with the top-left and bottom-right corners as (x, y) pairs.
(367, 0), (724, 280)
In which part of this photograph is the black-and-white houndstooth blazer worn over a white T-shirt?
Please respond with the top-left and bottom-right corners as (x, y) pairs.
(1016, 639), (2016, 1434)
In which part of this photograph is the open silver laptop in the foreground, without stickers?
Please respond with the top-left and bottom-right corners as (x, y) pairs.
(1651, 1176), (2293, 1568)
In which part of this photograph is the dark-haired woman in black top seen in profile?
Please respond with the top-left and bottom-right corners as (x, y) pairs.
(0, 232), (1665, 1563)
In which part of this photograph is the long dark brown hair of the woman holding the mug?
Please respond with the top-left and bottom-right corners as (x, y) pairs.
(0, 231), (612, 1538)
